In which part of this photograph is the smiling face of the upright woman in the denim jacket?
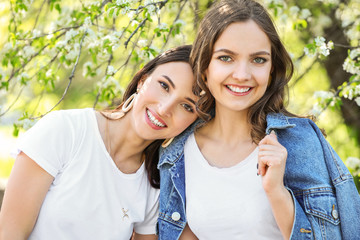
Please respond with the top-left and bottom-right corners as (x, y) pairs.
(205, 20), (272, 112)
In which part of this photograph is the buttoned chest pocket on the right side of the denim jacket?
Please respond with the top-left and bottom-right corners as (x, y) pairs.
(304, 188), (341, 240)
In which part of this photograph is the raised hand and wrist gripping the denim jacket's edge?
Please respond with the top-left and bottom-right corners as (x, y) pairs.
(258, 131), (287, 194)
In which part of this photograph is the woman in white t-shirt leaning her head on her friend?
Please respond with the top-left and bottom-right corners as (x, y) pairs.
(0, 46), (197, 240)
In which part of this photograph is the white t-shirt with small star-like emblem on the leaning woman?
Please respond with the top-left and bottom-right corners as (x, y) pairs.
(17, 109), (159, 240)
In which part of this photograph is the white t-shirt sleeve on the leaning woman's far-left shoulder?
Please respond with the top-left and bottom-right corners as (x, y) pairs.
(16, 111), (74, 177)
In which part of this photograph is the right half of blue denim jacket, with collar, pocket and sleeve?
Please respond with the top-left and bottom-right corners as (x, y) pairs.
(267, 115), (360, 240)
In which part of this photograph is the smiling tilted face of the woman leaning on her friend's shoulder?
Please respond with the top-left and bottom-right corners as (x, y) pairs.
(131, 62), (198, 140)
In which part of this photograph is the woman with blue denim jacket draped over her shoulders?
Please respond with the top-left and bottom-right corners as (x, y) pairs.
(158, 0), (360, 240)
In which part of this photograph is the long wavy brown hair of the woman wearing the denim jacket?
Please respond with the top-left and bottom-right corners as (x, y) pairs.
(190, 0), (294, 143)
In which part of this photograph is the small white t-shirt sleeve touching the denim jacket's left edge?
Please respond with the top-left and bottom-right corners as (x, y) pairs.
(134, 189), (160, 235)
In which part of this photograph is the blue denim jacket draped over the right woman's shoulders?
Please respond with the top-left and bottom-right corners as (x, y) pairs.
(157, 114), (360, 240)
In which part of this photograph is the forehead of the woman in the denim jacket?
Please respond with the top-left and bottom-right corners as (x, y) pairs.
(213, 20), (271, 51)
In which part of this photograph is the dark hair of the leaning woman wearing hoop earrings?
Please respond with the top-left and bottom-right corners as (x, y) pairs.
(108, 45), (191, 188)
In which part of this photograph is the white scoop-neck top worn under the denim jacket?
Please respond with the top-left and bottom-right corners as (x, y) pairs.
(184, 134), (283, 240)
